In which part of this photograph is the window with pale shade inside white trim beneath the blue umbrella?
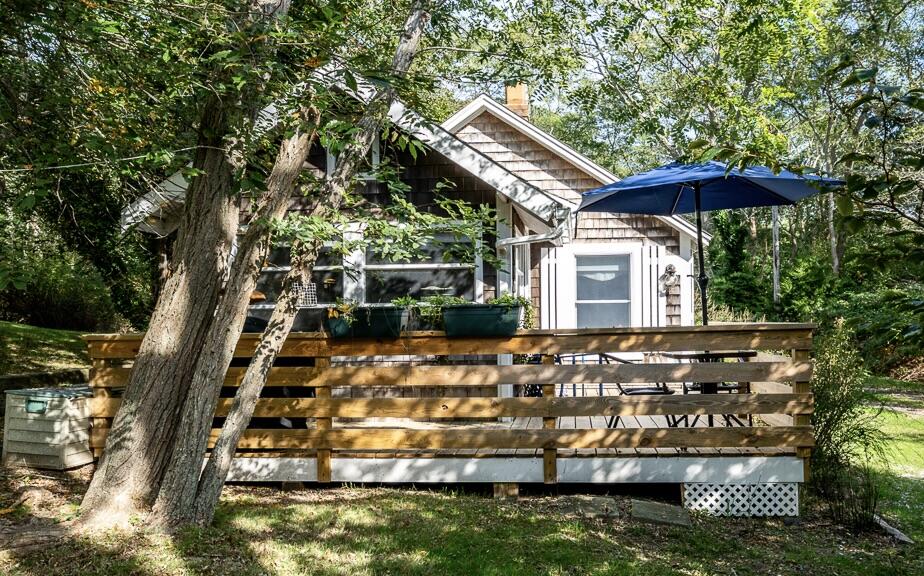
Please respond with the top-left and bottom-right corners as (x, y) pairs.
(575, 254), (632, 328)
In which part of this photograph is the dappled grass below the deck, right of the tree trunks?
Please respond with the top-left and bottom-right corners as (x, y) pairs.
(206, 489), (916, 575)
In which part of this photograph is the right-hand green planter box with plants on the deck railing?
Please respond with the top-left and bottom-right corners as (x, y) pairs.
(441, 294), (533, 338)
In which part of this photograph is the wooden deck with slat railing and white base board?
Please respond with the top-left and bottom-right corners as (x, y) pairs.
(87, 324), (813, 483)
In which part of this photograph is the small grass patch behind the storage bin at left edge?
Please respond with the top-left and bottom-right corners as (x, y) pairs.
(0, 322), (90, 375)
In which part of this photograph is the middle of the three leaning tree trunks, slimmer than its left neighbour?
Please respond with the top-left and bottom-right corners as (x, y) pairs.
(152, 110), (318, 526)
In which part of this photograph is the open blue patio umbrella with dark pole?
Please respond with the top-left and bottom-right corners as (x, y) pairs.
(578, 162), (844, 324)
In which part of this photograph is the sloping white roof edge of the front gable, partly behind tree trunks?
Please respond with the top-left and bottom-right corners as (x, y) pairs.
(122, 65), (574, 241)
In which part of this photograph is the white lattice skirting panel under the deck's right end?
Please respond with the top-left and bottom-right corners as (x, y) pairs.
(683, 482), (799, 516)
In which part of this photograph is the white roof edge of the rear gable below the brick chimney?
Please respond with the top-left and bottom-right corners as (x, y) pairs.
(442, 94), (711, 243)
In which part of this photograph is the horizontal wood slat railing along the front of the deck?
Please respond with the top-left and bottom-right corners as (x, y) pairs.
(85, 324), (814, 482)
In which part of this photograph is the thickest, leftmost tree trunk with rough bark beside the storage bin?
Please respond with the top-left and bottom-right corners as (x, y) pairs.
(81, 0), (289, 526)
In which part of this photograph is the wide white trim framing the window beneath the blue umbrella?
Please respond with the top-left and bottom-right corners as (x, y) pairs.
(555, 242), (642, 328)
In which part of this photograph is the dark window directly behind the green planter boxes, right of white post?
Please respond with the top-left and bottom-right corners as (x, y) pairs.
(363, 236), (476, 303)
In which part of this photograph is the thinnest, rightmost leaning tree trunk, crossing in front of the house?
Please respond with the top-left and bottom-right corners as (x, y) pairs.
(189, 2), (429, 525)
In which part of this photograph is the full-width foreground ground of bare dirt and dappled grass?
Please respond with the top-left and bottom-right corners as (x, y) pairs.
(0, 487), (924, 576)
